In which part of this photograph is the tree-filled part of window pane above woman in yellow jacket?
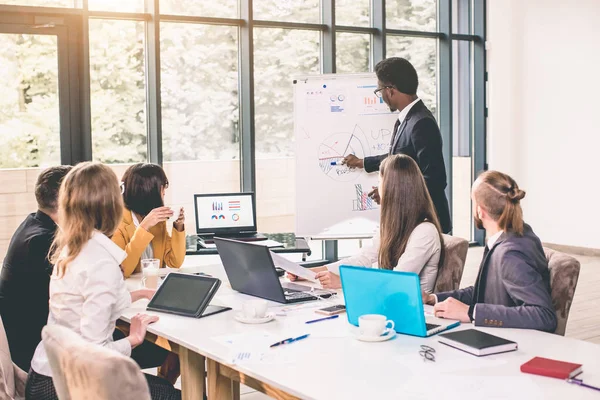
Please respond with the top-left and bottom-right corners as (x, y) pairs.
(89, 19), (147, 164)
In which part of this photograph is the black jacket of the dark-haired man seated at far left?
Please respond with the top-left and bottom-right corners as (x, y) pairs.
(0, 211), (56, 371)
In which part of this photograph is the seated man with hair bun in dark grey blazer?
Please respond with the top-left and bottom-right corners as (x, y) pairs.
(423, 171), (557, 332)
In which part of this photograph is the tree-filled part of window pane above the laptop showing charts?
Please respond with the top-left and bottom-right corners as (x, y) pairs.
(160, 23), (240, 163)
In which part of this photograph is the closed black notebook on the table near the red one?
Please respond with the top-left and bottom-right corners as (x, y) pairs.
(438, 329), (519, 356)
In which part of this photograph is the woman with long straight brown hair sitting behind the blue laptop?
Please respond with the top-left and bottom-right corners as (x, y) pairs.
(288, 154), (444, 293)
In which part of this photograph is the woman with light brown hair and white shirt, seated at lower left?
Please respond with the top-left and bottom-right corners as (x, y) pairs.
(26, 162), (181, 400)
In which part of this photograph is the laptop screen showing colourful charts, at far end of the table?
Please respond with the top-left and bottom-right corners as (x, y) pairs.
(194, 192), (256, 235)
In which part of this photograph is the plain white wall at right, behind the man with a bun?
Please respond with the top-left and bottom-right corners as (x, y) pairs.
(487, 0), (600, 249)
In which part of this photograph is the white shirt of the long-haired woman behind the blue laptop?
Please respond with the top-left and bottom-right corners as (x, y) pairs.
(327, 222), (441, 292)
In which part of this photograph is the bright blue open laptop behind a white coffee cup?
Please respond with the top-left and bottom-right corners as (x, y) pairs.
(340, 265), (460, 337)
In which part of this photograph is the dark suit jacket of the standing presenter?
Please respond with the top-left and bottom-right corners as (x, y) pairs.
(364, 100), (452, 233)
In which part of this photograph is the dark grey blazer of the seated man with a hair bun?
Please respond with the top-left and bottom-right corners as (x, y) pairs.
(437, 225), (557, 332)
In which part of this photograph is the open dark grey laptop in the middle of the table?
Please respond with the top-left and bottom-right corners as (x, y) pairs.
(214, 238), (332, 303)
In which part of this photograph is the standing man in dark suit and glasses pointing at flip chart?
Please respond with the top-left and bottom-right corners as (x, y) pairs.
(343, 57), (452, 233)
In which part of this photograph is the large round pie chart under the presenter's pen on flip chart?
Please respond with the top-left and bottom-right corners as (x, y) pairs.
(318, 129), (368, 182)
